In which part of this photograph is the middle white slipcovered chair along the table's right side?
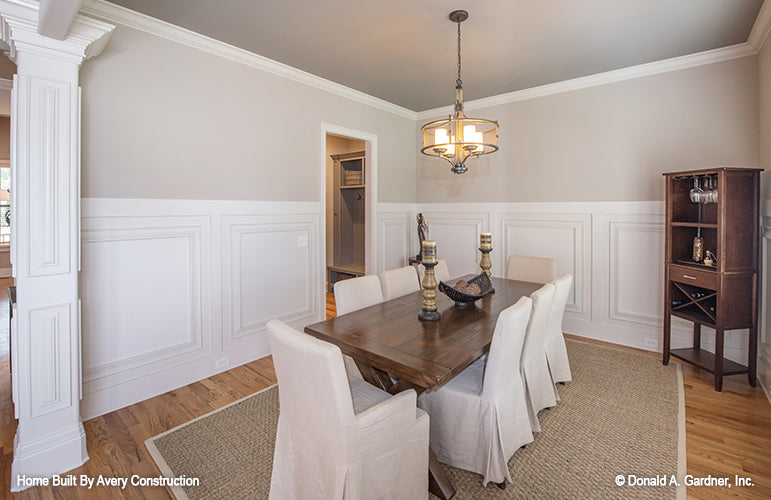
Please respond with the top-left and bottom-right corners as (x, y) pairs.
(521, 283), (559, 432)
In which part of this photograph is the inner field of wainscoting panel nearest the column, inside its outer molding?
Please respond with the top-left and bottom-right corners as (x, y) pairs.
(82, 227), (203, 382)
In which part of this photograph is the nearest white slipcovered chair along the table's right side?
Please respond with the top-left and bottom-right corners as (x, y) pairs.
(418, 297), (533, 486)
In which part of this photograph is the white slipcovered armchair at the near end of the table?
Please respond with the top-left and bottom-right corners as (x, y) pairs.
(268, 320), (429, 500)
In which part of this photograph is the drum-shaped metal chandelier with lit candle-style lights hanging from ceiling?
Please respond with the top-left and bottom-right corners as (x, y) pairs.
(420, 10), (498, 174)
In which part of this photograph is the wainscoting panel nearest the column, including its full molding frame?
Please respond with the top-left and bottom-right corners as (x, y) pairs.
(81, 216), (211, 394)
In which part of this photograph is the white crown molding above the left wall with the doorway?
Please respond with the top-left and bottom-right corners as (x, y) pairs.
(80, 0), (417, 120)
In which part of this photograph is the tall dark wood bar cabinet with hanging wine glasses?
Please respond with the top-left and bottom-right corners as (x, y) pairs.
(663, 167), (762, 391)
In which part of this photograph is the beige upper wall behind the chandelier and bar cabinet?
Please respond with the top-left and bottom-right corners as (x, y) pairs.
(416, 57), (759, 202)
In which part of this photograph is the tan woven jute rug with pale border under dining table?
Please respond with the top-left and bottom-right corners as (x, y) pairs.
(145, 341), (685, 500)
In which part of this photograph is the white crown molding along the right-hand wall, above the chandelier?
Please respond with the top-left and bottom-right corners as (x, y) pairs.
(418, 41), (765, 120)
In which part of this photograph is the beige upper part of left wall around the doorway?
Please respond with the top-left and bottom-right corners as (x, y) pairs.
(81, 26), (415, 202)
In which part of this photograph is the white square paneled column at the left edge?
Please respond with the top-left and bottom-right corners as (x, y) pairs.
(0, 0), (114, 491)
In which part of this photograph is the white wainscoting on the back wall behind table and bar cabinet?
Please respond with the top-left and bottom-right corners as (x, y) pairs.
(402, 202), (747, 363)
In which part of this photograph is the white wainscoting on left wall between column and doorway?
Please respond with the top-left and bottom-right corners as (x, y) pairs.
(81, 198), (325, 419)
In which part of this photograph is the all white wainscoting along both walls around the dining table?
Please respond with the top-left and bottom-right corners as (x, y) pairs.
(78, 199), (771, 418)
